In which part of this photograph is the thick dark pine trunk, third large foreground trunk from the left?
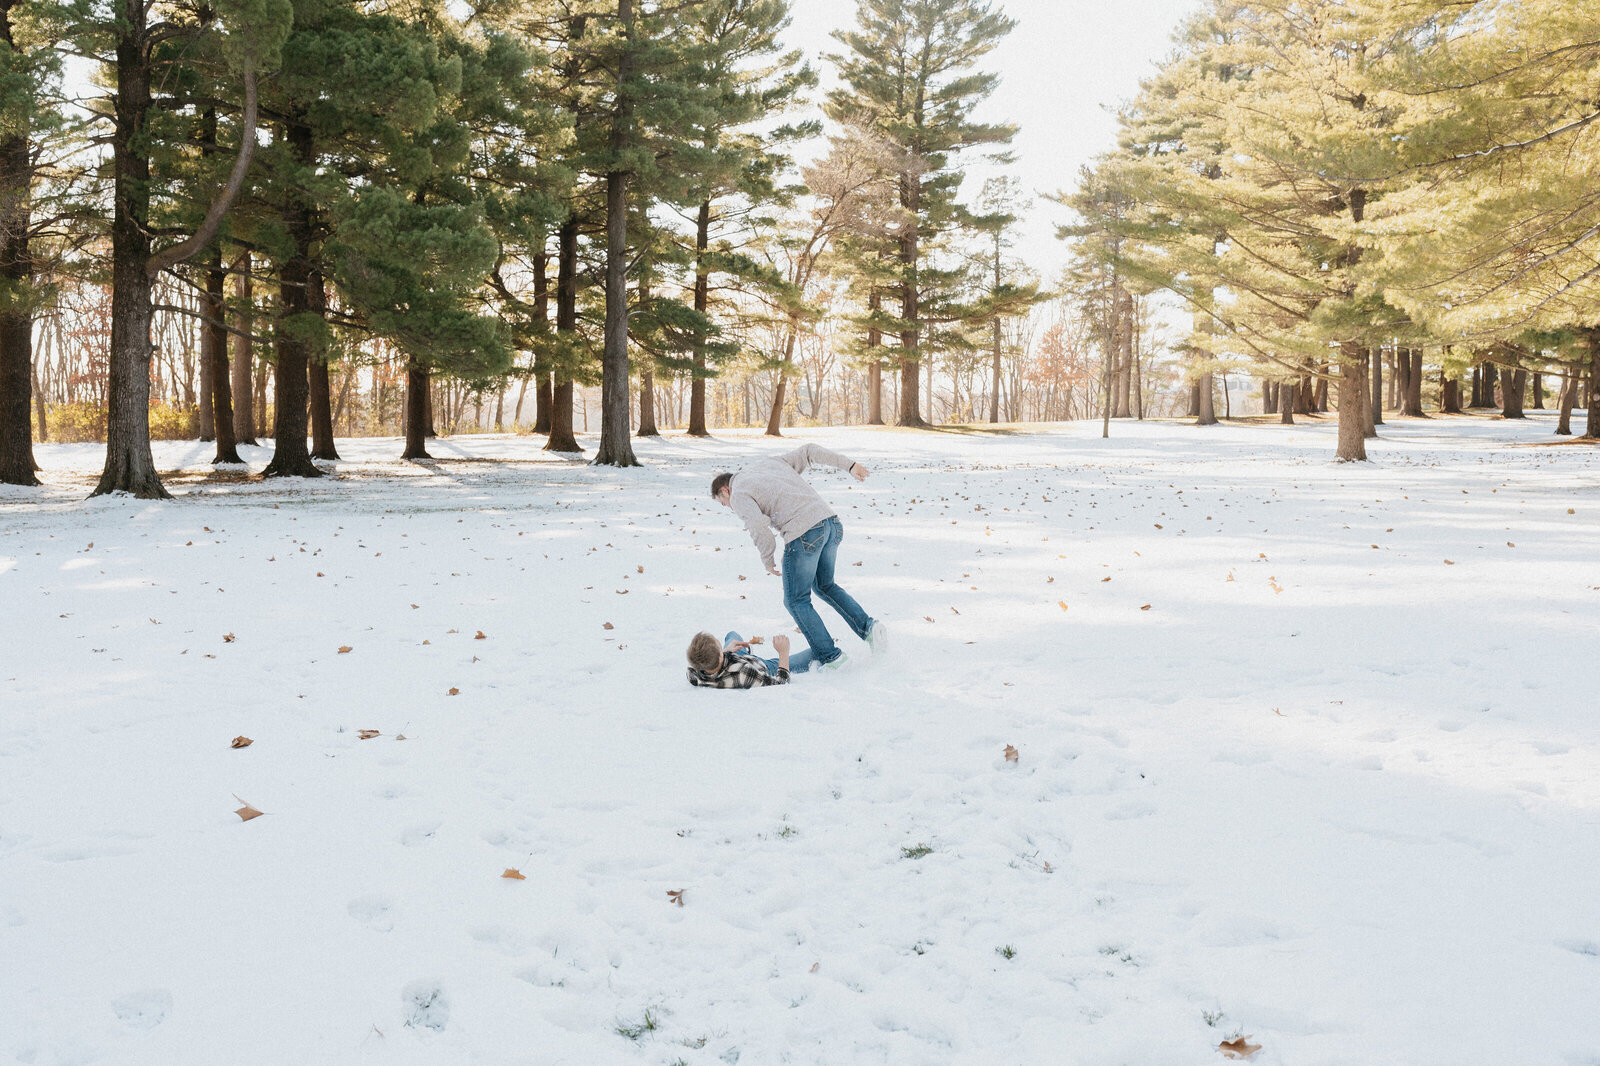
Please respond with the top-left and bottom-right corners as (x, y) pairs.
(262, 115), (322, 477)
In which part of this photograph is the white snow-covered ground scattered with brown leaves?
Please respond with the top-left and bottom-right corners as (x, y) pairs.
(9, 416), (1600, 1066)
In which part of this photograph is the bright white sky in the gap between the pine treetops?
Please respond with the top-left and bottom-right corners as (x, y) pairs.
(789, 0), (1202, 282)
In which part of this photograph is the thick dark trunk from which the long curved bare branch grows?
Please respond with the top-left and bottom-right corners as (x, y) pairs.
(91, 0), (171, 499)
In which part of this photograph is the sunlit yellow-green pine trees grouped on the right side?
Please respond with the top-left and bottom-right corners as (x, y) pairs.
(1059, 0), (1600, 459)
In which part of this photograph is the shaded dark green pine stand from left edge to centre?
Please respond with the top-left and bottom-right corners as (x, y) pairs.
(0, 0), (1045, 498)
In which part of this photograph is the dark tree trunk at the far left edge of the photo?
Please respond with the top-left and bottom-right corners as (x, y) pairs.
(0, 40), (38, 485)
